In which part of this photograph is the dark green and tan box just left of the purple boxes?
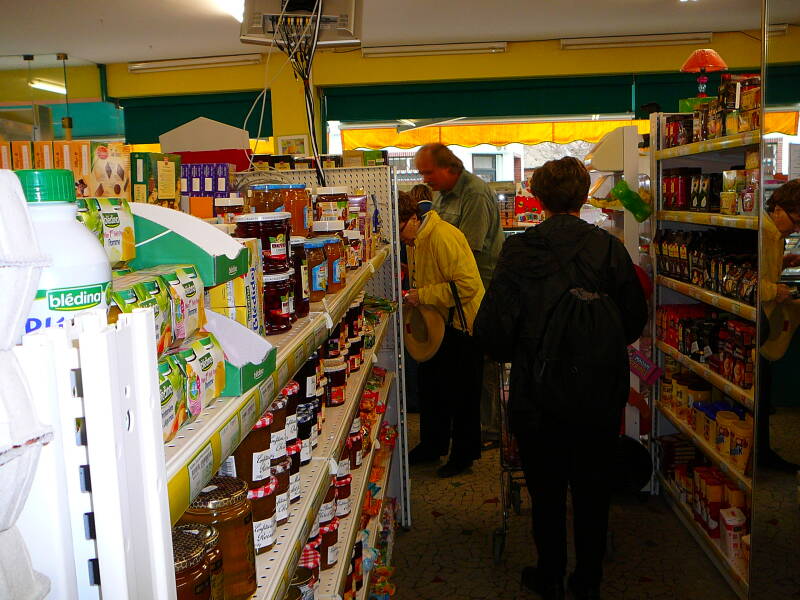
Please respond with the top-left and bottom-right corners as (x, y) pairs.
(131, 152), (182, 209)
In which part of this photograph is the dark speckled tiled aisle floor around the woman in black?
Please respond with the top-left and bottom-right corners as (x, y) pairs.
(393, 415), (736, 600)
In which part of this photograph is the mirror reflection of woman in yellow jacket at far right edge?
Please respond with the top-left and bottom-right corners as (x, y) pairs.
(756, 179), (800, 473)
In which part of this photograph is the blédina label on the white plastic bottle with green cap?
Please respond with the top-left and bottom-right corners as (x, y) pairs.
(25, 282), (109, 333)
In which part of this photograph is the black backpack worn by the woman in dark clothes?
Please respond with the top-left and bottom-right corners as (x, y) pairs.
(533, 232), (629, 426)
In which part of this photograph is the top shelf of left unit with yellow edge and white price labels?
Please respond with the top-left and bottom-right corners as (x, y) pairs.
(164, 246), (388, 523)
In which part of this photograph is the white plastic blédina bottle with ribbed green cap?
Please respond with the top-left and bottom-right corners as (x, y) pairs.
(15, 169), (111, 333)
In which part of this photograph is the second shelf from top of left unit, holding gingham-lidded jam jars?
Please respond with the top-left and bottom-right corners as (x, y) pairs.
(253, 317), (389, 600)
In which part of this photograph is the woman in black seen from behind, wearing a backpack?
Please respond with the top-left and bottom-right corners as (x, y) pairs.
(475, 157), (647, 600)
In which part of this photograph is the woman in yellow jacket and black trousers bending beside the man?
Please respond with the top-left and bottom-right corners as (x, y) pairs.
(398, 192), (484, 477)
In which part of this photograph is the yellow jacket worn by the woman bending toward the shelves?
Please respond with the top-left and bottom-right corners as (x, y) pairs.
(408, 210), (484, 333)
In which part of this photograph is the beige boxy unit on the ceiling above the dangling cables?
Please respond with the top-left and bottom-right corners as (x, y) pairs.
(239, 0), (362, 47)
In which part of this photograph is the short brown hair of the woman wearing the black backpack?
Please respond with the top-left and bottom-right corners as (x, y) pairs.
(531, 156), (591, 213)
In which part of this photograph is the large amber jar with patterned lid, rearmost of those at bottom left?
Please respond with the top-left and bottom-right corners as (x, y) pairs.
(180, 477), (258, 600)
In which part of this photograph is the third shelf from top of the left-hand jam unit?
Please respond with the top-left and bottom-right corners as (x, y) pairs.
(316, 372), (394, 600)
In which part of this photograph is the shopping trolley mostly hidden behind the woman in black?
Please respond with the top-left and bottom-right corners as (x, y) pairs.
(492, 363), (525, 564)
